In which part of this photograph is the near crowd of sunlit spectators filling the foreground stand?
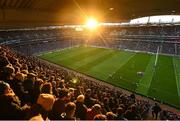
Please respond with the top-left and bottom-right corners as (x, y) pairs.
(0, 43), (180, 120)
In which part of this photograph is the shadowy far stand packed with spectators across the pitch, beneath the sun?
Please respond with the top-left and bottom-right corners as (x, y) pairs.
(0, 25), (180, 55)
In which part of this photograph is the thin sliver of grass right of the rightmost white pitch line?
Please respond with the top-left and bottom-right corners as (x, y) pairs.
(173, 57), (180, 102)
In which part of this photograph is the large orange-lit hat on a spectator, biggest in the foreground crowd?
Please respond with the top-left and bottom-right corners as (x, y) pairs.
(37, 94), (55, 111)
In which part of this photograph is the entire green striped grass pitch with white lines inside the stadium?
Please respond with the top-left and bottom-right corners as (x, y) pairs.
(39, 46), (180, 108)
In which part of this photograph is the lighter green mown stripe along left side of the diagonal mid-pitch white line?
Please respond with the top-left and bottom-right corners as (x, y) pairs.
(88, 51), (135, 82)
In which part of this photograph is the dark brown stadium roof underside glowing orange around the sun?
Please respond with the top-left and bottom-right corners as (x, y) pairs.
(0, 0), (180, 26)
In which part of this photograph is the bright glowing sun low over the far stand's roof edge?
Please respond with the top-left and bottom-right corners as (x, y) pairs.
(86, 18), (98, 30)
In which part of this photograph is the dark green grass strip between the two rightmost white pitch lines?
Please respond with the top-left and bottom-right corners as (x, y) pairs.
(148, 55), (180, 107)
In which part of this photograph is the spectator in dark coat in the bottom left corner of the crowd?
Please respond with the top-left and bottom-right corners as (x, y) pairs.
(0, 81), (29, 120)
